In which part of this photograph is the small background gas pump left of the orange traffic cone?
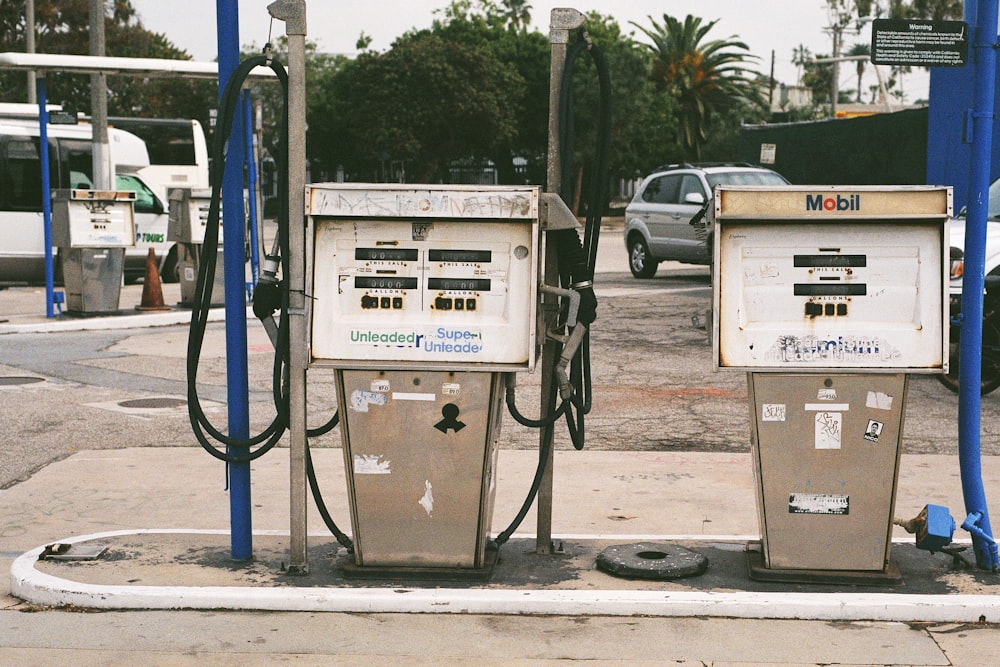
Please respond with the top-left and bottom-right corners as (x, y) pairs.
(52, 189), (135, 315)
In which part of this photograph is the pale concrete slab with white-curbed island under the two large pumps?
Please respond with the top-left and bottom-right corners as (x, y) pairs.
(0, 448), (1000, 623)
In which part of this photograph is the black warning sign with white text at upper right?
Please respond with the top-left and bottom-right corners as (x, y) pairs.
(872, 19), (969, 67)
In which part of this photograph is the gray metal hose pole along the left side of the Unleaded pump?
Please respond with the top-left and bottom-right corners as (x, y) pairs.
(267, 0), (309, 574)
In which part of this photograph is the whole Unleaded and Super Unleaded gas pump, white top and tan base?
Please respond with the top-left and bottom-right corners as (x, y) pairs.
(306, 183), (540, 569)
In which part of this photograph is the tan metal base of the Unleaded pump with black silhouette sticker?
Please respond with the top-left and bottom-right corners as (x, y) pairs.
(337, 370), (503, 568)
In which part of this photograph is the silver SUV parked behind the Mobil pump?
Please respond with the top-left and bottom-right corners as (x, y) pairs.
(625, 164), (788, 278)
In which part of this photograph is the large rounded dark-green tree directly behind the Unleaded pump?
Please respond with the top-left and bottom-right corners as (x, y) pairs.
(320, 33), (523, 182)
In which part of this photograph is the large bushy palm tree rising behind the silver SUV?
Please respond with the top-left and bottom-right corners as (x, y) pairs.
(632, 14), (766, 159)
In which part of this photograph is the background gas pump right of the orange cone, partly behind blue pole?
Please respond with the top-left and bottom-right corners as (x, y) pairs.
(167, 188), (225, 306)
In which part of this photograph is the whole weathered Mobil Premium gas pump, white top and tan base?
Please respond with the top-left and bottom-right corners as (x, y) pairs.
(713, 186), (952, 583)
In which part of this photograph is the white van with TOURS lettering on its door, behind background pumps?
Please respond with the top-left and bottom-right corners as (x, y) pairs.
(0, 117), (176, 284)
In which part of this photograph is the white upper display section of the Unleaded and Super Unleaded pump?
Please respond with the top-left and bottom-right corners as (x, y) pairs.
(309, 184), (538, 370)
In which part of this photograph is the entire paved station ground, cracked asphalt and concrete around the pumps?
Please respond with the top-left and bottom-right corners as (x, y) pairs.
(0, 228), (1000, 665)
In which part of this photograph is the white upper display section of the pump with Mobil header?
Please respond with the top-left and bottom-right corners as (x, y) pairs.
(715, 186), (951, 372)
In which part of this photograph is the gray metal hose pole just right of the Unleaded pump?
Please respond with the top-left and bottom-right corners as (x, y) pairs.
(535, 9), (586, 554)
